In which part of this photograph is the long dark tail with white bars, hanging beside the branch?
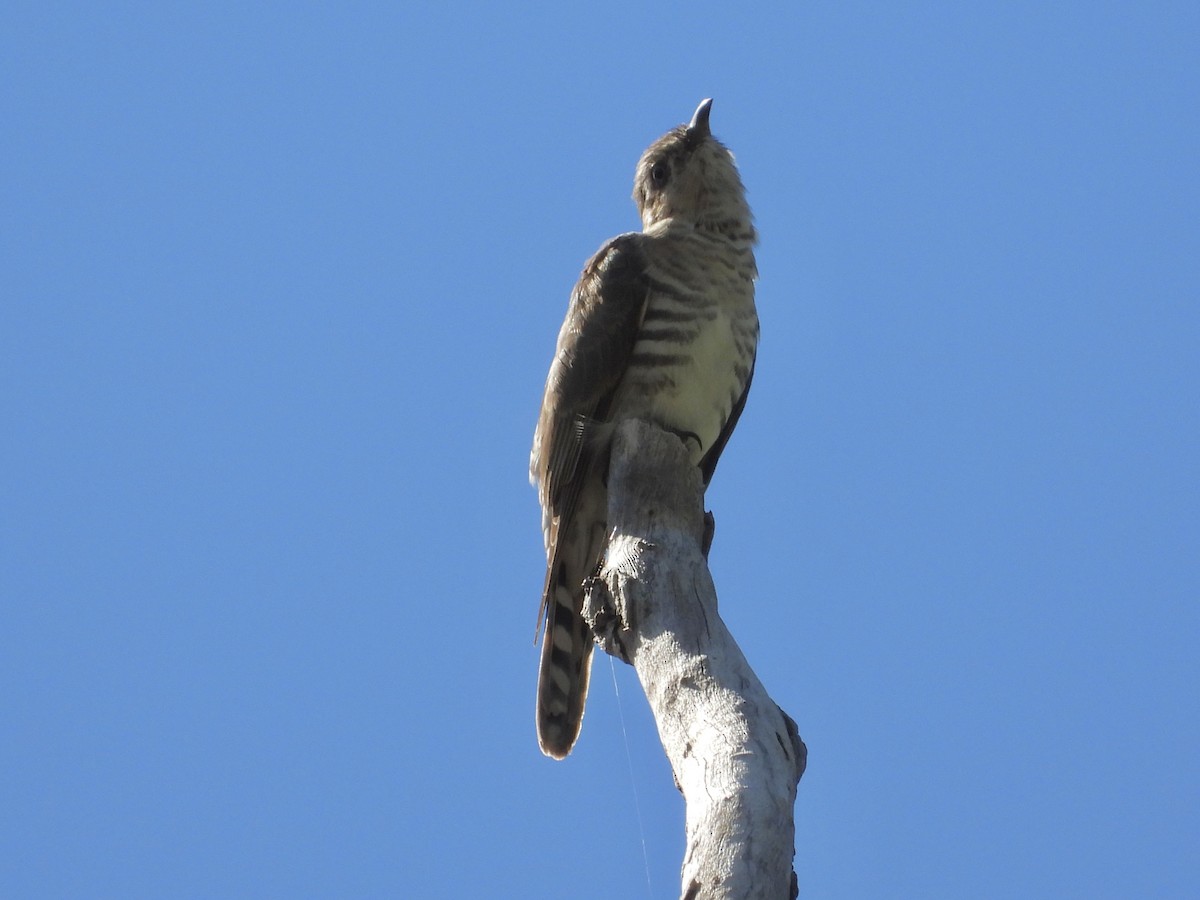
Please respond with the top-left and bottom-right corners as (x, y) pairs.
(538, 559), (593, 760)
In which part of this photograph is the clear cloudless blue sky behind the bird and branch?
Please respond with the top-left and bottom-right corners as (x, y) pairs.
(0, 1), (1200, 900)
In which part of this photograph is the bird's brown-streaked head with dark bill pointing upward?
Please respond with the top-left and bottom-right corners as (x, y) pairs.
(634, 100), (754, 242)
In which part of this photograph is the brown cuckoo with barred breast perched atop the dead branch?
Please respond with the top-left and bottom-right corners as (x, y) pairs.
(529, 98), (758, 760)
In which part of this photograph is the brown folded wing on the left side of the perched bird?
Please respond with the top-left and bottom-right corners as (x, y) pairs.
(529, 233), (650, 542)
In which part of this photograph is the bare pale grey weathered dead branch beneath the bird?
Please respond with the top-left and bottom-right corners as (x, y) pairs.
(584, 421), (806, 900)
